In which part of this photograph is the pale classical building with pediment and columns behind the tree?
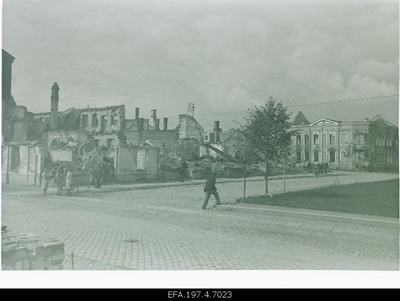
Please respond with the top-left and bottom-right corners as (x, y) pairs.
(292, 111), (398, 169)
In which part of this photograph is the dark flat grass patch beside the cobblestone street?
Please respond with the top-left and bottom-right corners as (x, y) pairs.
(238, 179), (399, 218)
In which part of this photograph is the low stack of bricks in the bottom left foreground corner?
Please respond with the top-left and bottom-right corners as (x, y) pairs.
(1, 231), (64, 270)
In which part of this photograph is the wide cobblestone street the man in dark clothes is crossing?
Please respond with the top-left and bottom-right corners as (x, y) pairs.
(2, 173), (399, 270)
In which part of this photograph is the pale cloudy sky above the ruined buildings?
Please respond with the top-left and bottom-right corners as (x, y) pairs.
(2, 0), (399, 129)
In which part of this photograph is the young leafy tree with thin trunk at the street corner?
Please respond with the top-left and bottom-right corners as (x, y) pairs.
(243, 97), (297, 195)
